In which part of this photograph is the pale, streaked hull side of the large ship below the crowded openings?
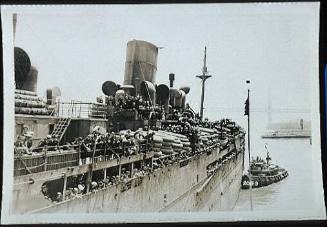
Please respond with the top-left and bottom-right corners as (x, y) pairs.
(13, 145), (244, 213)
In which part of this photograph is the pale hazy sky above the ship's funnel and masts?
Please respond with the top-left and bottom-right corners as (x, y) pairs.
(15, 3), (319, 123)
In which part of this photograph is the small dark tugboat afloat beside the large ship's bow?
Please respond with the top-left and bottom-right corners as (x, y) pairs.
(241, 146), (288, 189)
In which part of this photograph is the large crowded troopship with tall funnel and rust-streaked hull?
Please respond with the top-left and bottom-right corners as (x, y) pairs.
(11, 40), (245, 214)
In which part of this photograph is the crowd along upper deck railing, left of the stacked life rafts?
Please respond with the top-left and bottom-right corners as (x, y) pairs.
(14, 123), (154, 159)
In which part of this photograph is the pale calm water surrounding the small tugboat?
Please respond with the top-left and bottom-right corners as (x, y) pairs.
(235, 113), (315, 211)
